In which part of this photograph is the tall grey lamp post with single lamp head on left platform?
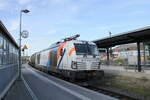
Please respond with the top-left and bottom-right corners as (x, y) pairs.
(19, 9), (30, 79)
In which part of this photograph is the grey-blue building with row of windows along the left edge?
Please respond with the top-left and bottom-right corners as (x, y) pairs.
(0, 21), (19, 100)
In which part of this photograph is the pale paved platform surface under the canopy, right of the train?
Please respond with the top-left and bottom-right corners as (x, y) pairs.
(101, 65), (150, 79)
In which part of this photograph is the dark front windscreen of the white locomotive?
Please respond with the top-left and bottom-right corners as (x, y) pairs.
(74, 43), (98, 55)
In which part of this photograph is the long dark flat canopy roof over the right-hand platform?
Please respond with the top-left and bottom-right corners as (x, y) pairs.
(93, 26), (150, 48)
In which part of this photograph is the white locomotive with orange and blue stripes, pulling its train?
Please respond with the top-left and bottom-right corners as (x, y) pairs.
(30, 35), (104, 79)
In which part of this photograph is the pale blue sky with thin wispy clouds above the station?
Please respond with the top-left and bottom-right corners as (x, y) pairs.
(0, 0), (150, 55)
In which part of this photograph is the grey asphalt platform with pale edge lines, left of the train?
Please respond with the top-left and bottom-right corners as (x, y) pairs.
(4, 64), (117, 100)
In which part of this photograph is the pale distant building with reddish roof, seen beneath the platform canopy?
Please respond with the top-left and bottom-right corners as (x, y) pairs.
(112, 43), (144, 65)
